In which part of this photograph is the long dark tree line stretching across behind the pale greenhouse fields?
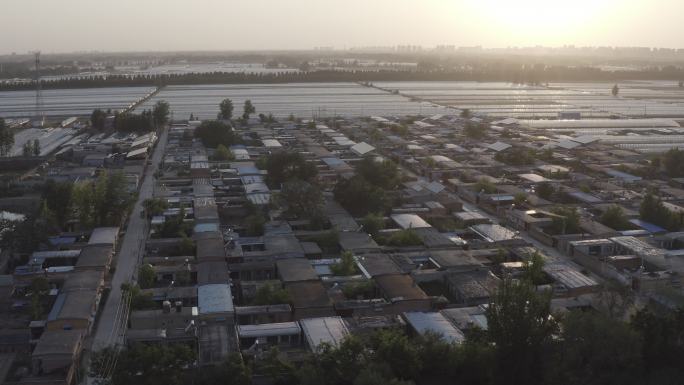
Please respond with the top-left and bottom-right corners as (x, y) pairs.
(0, 63), (684, 91)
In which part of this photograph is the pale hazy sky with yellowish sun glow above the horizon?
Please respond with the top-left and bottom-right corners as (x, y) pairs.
(0, 0), (684, 53)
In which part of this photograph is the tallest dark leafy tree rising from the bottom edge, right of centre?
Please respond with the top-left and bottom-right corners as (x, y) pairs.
(485, 279), (557, 384)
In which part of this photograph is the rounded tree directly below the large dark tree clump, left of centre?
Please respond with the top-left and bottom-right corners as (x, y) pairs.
(277, 179), (323, 219)
